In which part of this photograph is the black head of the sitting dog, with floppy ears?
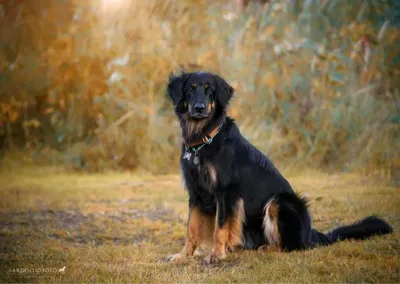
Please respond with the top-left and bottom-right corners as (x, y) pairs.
(168, 72), (233, 122)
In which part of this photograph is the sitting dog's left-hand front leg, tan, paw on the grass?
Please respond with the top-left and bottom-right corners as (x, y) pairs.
(167, 207), (215, 261)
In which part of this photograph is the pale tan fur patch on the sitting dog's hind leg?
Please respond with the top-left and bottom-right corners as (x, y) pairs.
(263, 200), (281, 248)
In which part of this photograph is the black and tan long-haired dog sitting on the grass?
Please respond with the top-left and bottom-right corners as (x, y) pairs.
(167, 72), (392, 264)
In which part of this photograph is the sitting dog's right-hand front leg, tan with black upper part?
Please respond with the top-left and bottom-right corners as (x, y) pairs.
(204, 198), (245, 264)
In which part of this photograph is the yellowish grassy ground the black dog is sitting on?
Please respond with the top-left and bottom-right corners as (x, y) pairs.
(0, 165), (400, 283)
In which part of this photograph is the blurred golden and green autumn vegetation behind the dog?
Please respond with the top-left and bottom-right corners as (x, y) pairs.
(0, 0), (400, 178)
